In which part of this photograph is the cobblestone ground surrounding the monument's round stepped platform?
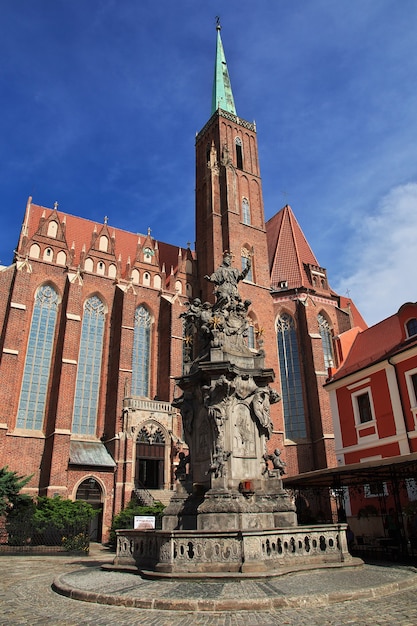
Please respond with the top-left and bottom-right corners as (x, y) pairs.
(0, 551), (417, 626)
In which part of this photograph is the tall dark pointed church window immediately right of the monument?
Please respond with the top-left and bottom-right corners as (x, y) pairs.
(277, 313), (307, 439)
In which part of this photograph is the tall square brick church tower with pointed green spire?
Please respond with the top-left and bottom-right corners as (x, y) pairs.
(196, 24), (277, 376)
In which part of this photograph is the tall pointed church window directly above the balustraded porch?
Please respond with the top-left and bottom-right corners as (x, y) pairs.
(132, 306), (152, 398)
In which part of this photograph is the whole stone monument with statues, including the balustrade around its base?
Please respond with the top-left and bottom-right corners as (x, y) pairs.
(113, 252), (356, 578)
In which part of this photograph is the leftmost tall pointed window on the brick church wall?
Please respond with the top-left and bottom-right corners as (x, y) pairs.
(16, 285), (59, 430)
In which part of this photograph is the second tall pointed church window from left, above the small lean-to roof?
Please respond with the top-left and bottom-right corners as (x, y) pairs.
(72, 296), (105, 435)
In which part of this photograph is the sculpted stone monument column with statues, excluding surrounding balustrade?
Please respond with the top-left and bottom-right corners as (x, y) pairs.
(163, 252), (296, 530)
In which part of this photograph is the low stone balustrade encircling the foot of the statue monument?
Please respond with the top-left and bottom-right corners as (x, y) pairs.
(114, 524), (356, 576)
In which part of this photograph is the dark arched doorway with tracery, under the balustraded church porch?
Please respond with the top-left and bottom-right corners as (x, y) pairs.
(136, 427), (165, 489)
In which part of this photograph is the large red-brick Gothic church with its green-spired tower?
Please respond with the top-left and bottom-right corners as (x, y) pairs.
(0, 25), (366, 541)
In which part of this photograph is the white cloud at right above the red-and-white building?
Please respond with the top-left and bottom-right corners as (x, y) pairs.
(336, 183), (417, 325)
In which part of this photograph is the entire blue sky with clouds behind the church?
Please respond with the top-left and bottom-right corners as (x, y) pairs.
(0, 0), (417, 324)
